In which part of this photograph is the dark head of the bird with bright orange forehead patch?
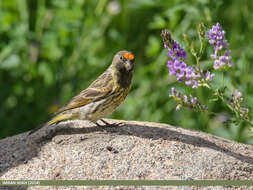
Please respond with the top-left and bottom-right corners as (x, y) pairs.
(112, 50), (135, 72)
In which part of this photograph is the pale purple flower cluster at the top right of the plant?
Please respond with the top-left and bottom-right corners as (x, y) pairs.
(207, 23), (232, 70)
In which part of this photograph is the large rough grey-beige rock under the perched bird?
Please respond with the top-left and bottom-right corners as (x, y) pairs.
(0, 119), (253, 189)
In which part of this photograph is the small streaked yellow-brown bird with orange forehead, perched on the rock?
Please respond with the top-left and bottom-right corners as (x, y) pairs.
(29, 50), (135, 135)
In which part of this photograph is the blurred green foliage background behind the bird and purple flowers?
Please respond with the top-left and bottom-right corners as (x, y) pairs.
(0, 0), (253, 144)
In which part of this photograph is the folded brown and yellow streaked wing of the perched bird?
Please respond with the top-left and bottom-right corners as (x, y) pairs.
(56, 71), (113, 114)
